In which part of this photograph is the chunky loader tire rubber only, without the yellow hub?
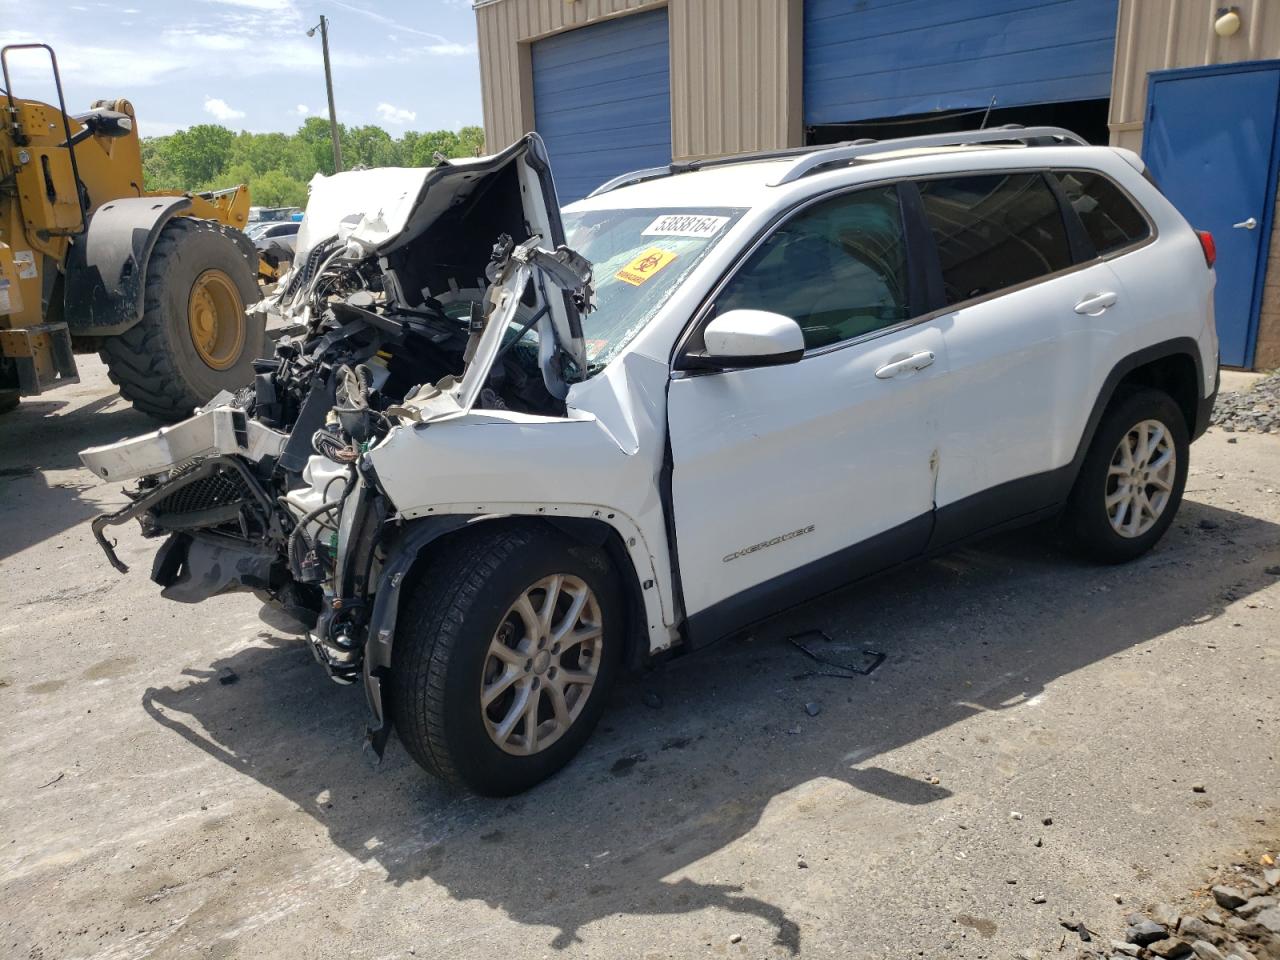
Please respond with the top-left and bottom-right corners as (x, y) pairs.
(101, 216), (266, 422)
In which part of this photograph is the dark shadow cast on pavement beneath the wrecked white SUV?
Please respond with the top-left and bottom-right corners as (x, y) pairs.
(143, 502), (1280, 954)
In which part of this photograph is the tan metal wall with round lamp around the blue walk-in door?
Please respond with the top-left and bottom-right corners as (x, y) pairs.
(1110, 0), (1280, 150)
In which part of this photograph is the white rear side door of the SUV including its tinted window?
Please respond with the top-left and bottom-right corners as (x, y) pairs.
(918, 170), (1126, 547)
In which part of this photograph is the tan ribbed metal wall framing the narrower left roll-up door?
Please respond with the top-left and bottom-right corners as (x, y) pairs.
(475, 0), (804, 160)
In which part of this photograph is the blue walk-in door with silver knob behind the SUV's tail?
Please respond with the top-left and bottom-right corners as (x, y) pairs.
(1142, 60), (1280, 367)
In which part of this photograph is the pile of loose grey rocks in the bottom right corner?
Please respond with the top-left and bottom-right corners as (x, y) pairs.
(1085, 854), (1280, 960)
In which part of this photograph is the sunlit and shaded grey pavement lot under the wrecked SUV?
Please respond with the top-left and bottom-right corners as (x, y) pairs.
(0, 362), (1280, 960)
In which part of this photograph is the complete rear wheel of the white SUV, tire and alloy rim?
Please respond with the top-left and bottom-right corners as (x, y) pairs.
(1066, 389), (1190, 563)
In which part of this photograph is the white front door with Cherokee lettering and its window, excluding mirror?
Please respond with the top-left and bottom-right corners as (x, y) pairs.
(667, 187), (946, 645)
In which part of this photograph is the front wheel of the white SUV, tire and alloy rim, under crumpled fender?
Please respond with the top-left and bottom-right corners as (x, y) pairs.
(390, 521), (623, 796)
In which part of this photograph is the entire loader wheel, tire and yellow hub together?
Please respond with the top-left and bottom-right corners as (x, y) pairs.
(102, 216), (266, 421)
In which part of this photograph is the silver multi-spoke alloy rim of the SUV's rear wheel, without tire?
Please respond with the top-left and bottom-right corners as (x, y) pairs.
(1105, 420), (1178, 539)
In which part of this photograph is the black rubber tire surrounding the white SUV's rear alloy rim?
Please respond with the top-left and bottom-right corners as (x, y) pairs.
(1065, 388), (1190, 563)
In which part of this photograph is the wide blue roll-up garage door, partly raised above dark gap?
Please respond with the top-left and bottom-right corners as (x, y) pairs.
(804, 0), (1117, 125)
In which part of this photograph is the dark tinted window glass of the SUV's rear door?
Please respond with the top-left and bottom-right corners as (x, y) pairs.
(919, 173), (1071, 305)
